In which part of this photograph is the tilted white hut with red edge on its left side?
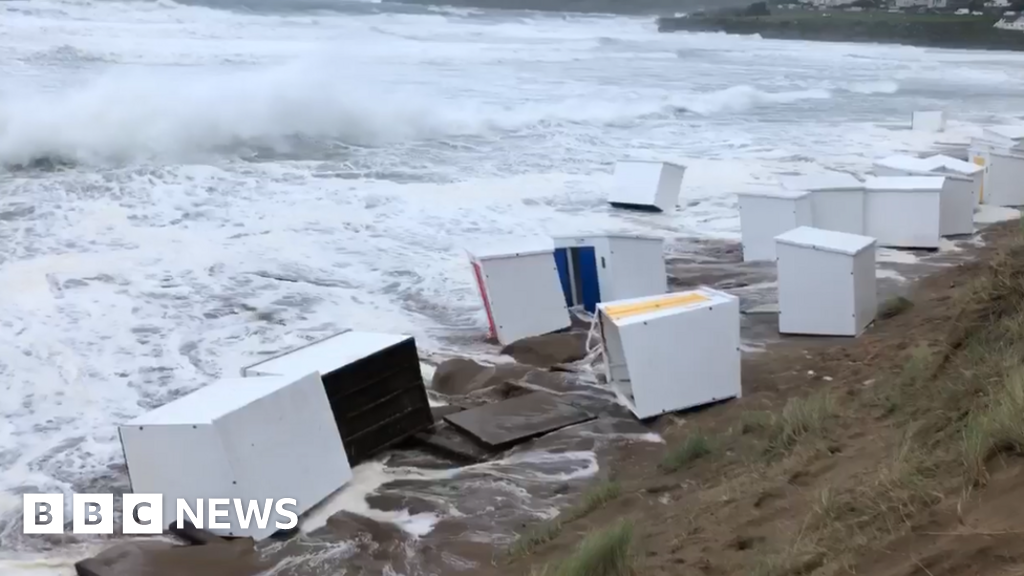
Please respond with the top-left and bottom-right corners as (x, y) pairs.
(469, 241), (571, 345)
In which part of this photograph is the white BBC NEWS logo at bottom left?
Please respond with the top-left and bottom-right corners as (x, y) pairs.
(23, 494), (299, 534)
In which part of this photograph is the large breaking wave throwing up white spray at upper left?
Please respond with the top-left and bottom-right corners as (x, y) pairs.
(0, 55), (830, 166)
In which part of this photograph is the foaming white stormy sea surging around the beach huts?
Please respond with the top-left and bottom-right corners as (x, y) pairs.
(0, 0), (1024, 573)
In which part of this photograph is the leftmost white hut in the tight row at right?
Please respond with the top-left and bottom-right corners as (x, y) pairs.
(736, 189), (814, 262)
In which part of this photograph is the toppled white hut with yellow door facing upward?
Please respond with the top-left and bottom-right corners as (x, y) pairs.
(598, 288), (741, 419)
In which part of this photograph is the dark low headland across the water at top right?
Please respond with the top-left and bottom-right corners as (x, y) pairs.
(657, 10), (1024, 51)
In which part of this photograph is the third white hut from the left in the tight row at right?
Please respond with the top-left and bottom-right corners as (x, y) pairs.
(864, 176), (945, 249)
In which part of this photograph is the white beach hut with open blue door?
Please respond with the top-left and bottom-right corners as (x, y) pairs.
(553, 234), (669, 313)
